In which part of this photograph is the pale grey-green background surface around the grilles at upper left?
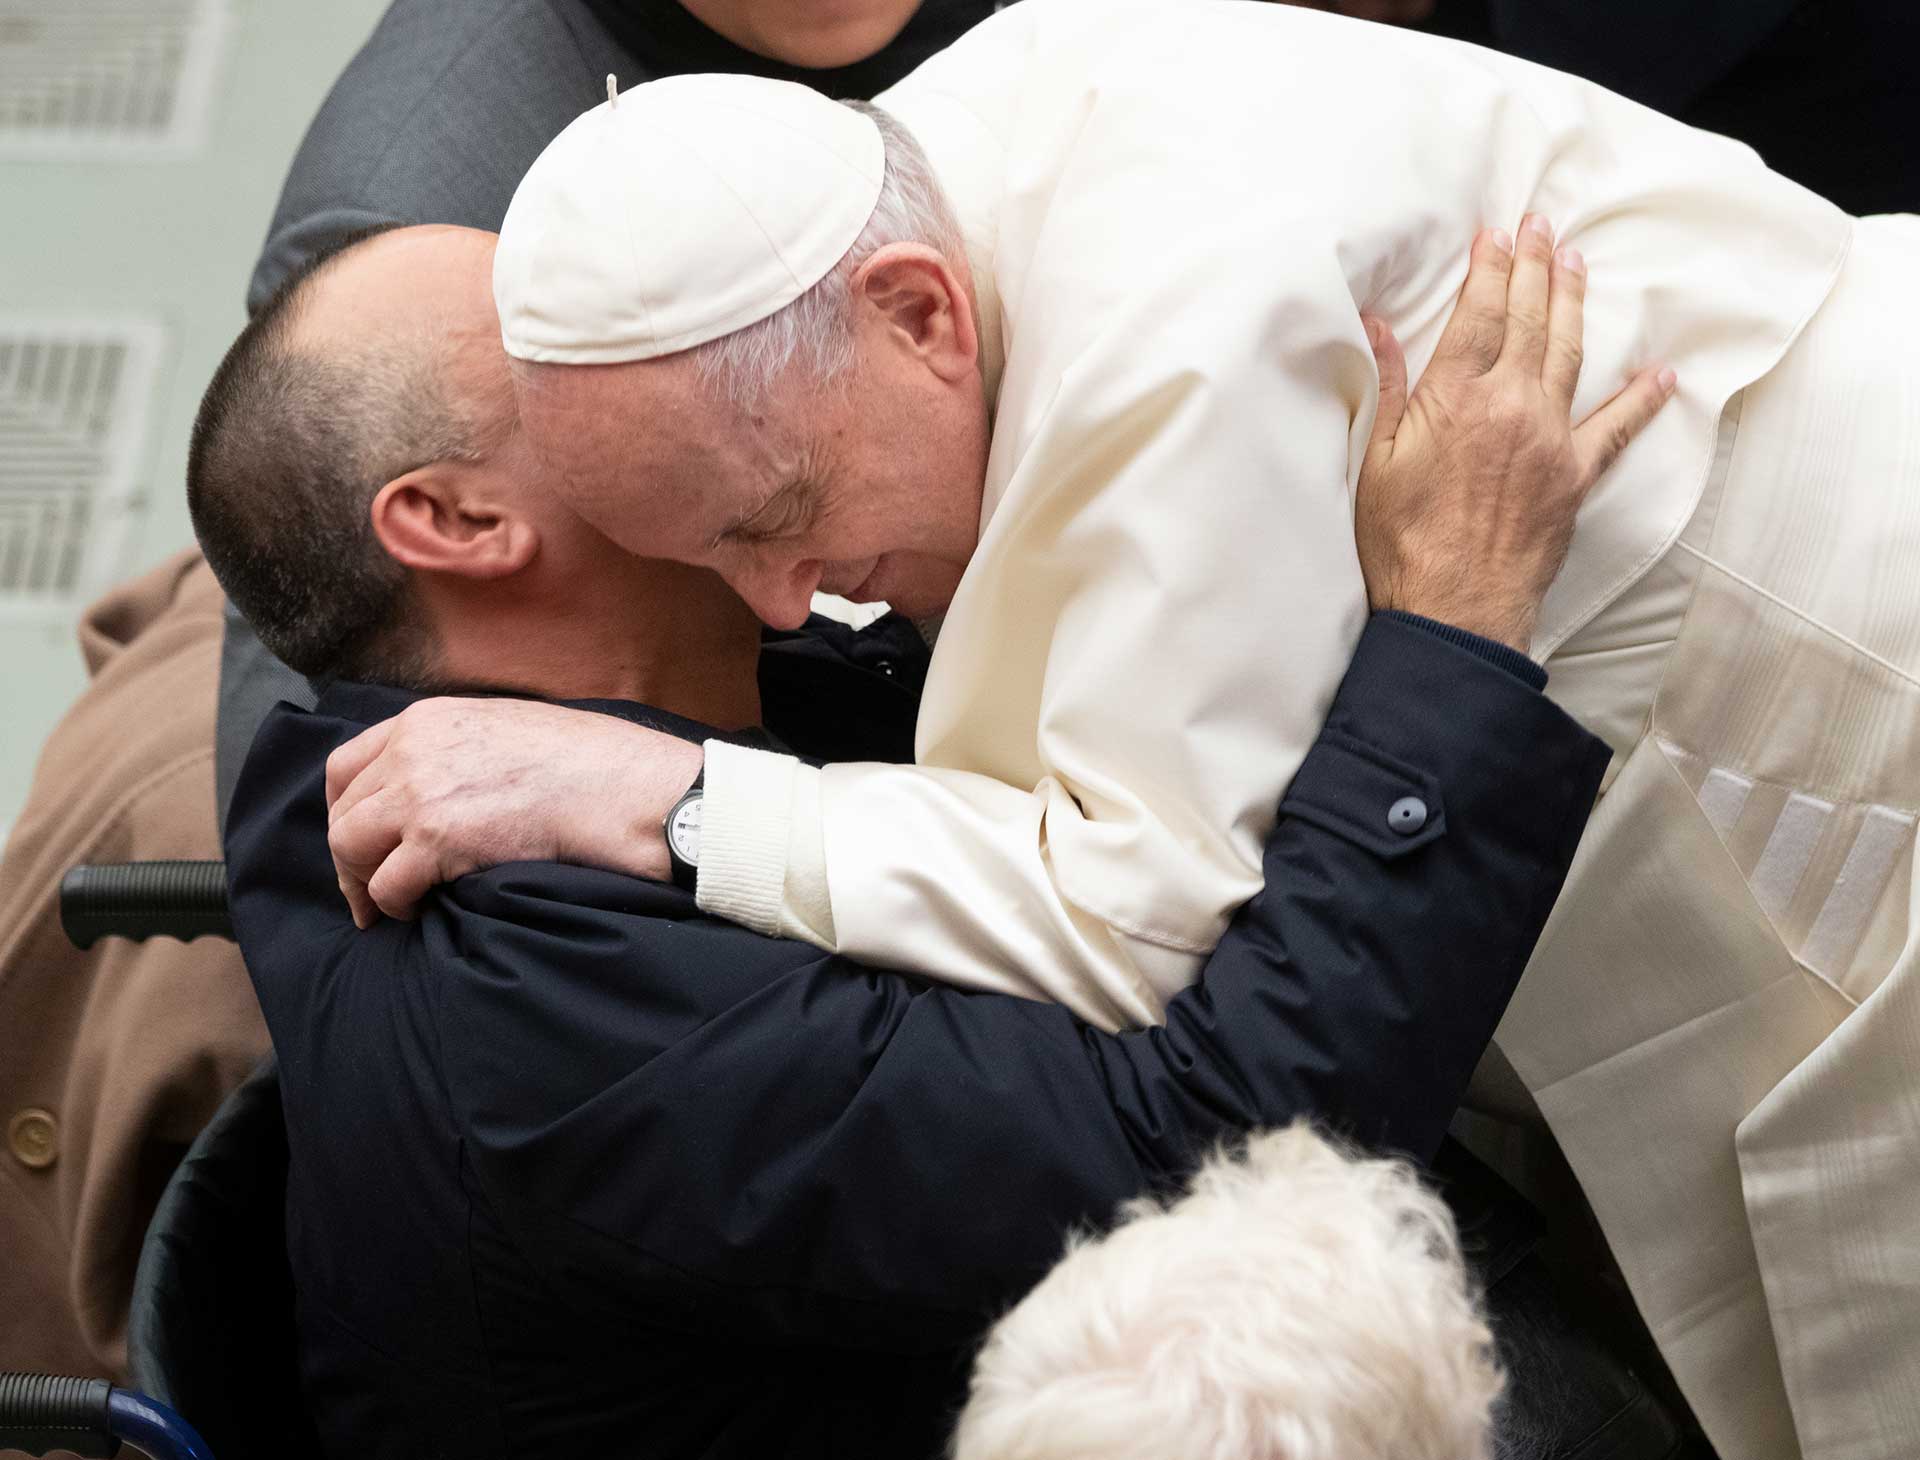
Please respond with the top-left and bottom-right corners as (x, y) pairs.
(0, 0), (386, 836)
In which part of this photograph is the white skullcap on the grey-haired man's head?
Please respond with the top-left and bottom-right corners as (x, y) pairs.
(493, 75), (885, 365)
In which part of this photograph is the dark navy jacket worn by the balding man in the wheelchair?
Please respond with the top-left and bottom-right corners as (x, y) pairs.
(228, 619), (1607, 1460)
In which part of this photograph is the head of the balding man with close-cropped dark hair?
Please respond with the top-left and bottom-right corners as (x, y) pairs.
(188, 227), (756, 720)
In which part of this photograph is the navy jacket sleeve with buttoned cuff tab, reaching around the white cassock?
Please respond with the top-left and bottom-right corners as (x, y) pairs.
(434, 621), (1607, 1352)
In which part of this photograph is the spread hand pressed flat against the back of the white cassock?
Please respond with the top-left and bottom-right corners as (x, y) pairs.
(1354, 215), (1674, 653)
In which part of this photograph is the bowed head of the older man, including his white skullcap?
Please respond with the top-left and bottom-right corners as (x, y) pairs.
(495, 88), (989, 626)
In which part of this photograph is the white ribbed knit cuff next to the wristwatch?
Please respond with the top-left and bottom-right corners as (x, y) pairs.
(695, 740), (798, 936)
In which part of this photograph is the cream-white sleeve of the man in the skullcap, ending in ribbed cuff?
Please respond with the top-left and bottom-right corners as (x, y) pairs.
(701, 222), (1377, 1030)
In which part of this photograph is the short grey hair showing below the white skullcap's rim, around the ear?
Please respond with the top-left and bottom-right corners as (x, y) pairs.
(687, 102), (966, 409)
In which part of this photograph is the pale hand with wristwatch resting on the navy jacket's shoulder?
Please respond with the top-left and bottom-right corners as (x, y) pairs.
(326, 699), (703, 928)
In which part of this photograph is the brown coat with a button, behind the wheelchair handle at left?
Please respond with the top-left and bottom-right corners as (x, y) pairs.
(0, 551), (267, 1377)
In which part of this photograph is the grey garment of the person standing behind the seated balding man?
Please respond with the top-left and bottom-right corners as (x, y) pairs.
(215, 0), (641, 826)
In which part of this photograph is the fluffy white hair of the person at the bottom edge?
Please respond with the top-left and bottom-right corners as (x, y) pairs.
(952, 1124), (1501, 1460)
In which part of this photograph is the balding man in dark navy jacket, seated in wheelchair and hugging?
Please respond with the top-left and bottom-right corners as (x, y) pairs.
(188, 214), (1704, 1460)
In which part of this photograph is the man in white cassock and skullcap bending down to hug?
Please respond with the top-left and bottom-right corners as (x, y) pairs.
(334, 0), (1920, 1460)
